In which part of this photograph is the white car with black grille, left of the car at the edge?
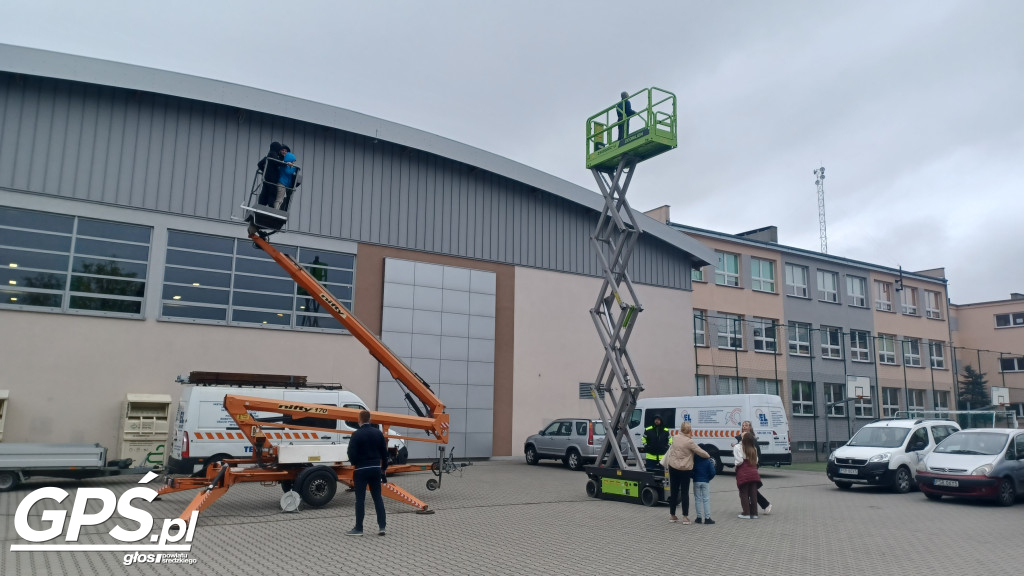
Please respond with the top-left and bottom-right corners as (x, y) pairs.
(825, 419), (959, 494)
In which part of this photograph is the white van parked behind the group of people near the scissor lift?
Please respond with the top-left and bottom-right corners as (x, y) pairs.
(629, 394), (793, 471)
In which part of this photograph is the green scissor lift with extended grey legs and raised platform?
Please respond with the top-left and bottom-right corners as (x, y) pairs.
(586, 88), (676, 506)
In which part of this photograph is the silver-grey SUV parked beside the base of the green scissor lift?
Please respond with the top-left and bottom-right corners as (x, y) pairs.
(522, 418), (604, 470)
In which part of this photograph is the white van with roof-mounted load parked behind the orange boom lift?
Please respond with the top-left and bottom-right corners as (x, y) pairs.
(167, 385), (409, 475)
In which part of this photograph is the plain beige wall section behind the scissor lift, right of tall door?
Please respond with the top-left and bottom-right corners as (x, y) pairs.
(509, 268), (696, 446)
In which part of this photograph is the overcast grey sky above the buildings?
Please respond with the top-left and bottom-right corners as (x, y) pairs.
(0, 0), (1024, 303)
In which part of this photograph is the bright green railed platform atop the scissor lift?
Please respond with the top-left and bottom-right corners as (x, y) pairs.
(587, 87), (678, 170)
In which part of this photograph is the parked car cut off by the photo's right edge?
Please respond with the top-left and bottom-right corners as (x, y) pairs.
(918, 428), (1024, 506)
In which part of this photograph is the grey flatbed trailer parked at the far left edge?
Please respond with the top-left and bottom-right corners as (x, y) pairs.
(0, 443), (131, 492)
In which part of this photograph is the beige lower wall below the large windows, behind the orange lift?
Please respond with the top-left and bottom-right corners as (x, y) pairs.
(0, 311), (377, 448)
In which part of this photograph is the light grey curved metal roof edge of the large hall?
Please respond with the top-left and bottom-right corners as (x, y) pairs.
(0, 44), (714, 265)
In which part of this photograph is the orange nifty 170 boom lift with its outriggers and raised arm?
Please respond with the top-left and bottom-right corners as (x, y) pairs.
(154, 228), (449, 521)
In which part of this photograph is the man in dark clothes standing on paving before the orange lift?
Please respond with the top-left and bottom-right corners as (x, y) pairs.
(346, 410), (387, 536)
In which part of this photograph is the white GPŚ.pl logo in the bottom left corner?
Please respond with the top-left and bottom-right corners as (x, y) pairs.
(10, 472), (199, 562)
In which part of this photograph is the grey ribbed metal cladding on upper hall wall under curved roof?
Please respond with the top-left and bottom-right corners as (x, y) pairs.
(0, 73), (689, 288)
